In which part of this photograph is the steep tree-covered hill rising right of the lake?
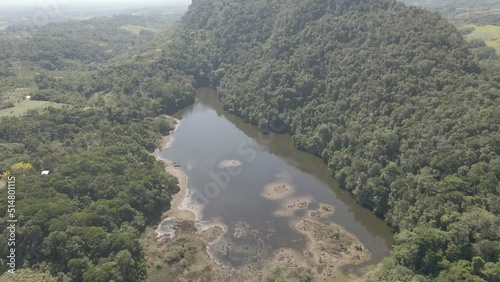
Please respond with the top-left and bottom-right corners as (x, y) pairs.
(174, 0), (500, 281)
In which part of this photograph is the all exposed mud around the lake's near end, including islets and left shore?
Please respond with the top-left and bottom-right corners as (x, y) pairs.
(141, 115), (371, 282)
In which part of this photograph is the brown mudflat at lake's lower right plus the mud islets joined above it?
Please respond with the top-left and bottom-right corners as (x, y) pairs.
(261, 178), (371, 281)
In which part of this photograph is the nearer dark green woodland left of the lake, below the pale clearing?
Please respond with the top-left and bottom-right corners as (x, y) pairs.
(0, 108), (184, 281)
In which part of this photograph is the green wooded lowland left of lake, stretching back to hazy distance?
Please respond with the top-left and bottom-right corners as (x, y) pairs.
(0, 9), (195, 282)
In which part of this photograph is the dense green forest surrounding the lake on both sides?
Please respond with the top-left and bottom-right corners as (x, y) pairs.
(0, 0), (500, 281)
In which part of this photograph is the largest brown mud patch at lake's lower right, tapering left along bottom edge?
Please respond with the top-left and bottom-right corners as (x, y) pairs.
(209, 219), (370, 282)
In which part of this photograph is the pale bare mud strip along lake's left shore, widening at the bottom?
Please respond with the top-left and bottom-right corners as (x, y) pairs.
(141, 120), (225, 282)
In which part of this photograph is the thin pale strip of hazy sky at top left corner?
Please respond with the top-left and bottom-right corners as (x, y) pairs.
(0, 0), (191, 7)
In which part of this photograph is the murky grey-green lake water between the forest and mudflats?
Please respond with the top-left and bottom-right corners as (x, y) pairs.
(160, 89), (393, 269)
